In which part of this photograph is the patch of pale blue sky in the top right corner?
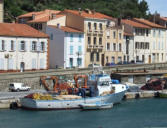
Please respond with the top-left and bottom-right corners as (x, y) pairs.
(145, 0), (167, 17)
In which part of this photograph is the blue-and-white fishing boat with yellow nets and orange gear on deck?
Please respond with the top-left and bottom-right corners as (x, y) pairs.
(20, 74), (128, 110)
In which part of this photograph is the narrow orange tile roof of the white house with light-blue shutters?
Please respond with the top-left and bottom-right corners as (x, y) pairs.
(49, 25), (83, 33)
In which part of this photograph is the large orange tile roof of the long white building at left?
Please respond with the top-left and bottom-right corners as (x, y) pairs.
(0, 23), (48, 38)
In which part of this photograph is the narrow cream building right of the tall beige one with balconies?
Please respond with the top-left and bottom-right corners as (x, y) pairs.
(105, 24), (124, 64)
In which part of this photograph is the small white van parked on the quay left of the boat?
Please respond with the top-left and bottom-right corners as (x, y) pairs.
(9, 83), (31, 92)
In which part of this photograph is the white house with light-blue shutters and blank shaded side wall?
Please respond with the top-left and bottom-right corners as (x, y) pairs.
(46, 24), (85, 68)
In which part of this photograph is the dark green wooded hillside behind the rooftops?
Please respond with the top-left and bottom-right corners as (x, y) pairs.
(4, 0), (149, 22)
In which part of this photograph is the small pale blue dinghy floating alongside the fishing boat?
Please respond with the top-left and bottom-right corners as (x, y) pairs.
(79, 103), (113, 110)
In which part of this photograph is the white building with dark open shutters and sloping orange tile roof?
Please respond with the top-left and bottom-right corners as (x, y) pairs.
(123, 20), (151, 63)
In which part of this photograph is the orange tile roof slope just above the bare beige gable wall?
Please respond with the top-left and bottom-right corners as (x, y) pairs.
(28, 15), (64, 23)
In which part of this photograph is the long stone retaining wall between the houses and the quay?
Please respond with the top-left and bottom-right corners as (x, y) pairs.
(0, 63), (167, 91)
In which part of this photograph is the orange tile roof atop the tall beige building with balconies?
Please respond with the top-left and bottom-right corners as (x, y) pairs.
(64, 10), (114, 20)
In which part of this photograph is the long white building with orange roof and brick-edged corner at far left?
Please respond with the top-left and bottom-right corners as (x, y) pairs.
(0, 23), (49, 72)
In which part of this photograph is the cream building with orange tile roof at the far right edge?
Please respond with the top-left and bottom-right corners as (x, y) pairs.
(133, 18), (167, 63)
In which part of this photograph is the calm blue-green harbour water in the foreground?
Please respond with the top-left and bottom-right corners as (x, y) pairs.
(0, 99), (167, 128)
